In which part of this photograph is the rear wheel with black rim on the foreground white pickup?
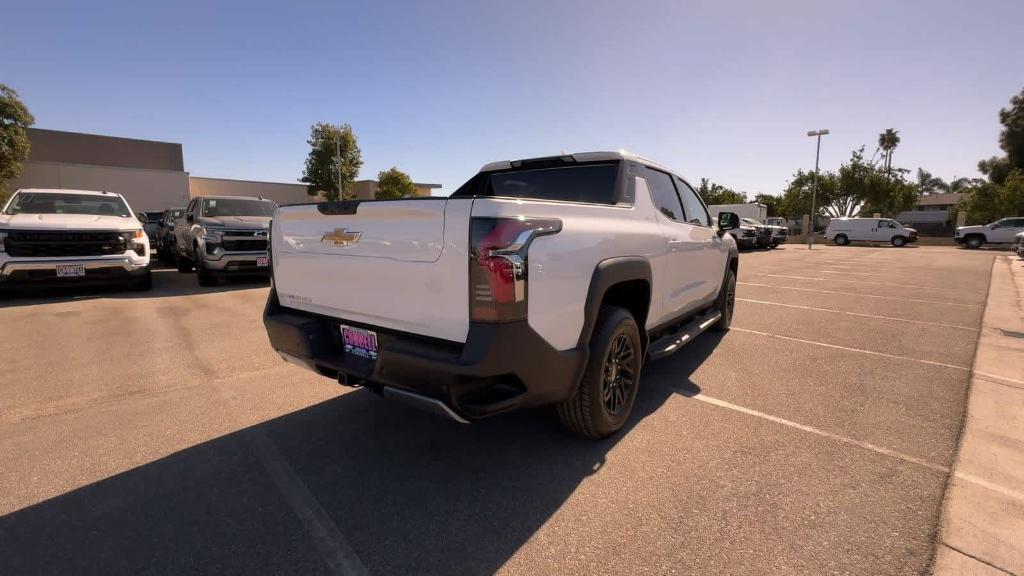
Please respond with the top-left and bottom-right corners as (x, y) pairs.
(558, 306), (643, 439)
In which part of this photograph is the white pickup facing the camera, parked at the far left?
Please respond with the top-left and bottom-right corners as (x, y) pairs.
(0, 189), (153, 290)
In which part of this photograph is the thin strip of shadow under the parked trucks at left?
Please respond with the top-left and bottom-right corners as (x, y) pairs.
(0, 269), (269, 308)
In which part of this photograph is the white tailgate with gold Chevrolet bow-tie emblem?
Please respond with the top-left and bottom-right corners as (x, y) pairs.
(271, 198), (473, 342)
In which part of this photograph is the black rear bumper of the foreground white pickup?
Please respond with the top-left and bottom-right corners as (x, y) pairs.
(263, 290), (587, 419)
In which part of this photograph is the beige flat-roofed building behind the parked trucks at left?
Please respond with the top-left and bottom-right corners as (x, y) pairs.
(8, 128), (440, 212)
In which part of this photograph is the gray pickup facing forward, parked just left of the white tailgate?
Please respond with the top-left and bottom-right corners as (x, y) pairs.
(174, 196), (278, 286)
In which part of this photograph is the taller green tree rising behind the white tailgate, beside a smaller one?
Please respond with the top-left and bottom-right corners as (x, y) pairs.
(299, 122), (362, 201)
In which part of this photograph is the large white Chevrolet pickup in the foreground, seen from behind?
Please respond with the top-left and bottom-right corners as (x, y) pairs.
(263, 152), (739, 438)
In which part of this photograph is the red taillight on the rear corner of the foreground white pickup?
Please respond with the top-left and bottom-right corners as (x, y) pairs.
(469, 218), (562, 322)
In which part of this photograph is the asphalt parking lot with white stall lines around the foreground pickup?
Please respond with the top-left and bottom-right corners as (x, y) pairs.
(0, 245), (994, 575)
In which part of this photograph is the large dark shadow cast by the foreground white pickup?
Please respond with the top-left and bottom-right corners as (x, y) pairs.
(0, 333), (721, 575)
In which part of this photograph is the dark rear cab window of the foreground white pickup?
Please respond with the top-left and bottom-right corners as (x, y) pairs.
(452, 163), (618, 204)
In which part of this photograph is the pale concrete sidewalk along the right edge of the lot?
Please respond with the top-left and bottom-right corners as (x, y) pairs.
(934, 254), (1024, 576)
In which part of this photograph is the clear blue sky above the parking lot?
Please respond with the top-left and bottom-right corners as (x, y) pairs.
(0, 0), (1024, 194)
